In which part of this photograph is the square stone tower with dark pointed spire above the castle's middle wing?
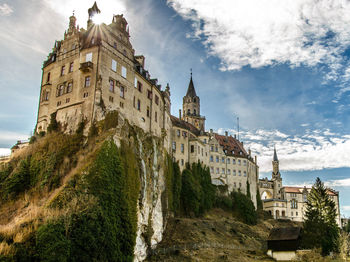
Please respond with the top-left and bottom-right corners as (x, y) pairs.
(182, 70), (205, 131)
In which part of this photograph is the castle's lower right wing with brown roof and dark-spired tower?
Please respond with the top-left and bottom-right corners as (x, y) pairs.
(171, 75), (259, 206)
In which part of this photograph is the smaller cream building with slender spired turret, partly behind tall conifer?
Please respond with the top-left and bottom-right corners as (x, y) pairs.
(259, 148), (341, 226)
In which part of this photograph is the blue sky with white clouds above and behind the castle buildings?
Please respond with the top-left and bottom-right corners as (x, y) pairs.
(0, 0), (350, 217)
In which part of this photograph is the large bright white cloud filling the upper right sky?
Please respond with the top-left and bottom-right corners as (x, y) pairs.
(167, 0), (350, 93)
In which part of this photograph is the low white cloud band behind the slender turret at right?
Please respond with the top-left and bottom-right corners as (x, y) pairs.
(219, 129), (350, 173)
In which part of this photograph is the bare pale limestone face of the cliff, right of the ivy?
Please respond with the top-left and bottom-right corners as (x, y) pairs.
(114, 122), (167, 261)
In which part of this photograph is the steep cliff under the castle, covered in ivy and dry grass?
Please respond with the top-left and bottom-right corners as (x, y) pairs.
(0, 112), (169, 261)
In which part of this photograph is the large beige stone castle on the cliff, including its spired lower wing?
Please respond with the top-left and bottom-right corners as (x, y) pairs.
(36, 2), (259, 206)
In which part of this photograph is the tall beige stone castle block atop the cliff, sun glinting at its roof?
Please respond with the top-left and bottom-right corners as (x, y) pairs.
(36, 9), (171, 151)
